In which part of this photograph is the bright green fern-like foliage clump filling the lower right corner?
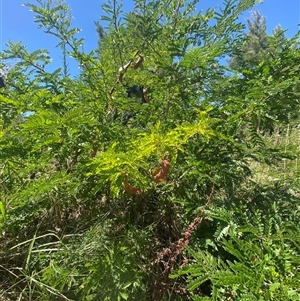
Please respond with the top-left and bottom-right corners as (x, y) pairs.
(172, 187), (300, 300)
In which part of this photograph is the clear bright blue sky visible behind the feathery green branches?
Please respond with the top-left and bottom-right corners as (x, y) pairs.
(0, 0), (300, 74)
